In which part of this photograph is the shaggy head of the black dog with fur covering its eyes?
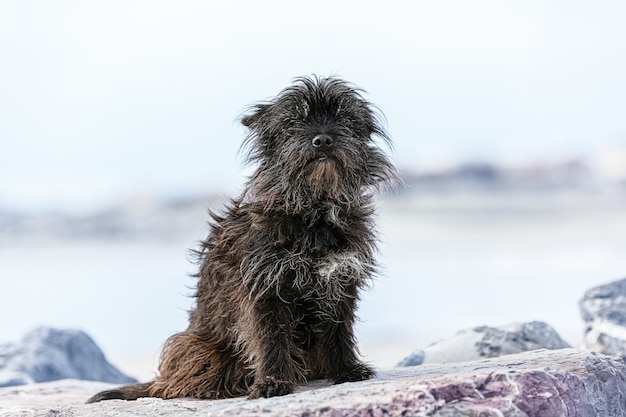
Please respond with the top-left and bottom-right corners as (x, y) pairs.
(242, 77), (397, 205)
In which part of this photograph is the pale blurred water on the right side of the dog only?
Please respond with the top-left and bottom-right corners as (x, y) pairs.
(360, 192), (626, 366)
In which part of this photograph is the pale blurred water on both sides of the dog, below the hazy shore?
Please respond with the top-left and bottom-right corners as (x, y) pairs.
(0, 191), (626, 380)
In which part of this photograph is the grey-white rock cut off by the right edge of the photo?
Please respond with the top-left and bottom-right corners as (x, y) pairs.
(580, 278), (626, 359)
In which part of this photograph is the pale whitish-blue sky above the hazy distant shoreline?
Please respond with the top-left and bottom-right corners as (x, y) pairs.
(0, 0), (626, 211)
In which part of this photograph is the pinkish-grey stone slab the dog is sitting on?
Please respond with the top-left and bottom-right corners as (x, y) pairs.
(0, 349), (626, 417)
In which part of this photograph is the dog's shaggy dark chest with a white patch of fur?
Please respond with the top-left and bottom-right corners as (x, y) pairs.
(249, 207), (374, 304)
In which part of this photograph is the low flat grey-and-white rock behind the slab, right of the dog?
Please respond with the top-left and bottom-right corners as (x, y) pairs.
(397, 321), (570, 366)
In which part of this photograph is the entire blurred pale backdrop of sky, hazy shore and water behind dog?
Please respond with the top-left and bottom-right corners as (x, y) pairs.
(0, 0), (626, 379)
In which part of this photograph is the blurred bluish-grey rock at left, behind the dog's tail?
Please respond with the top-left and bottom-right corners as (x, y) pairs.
(0, 327), (135, 387)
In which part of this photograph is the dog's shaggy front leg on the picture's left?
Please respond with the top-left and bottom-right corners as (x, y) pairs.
(248, 296), (305, 398)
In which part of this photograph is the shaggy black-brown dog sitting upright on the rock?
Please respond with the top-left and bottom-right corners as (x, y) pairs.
(89, 77), (397, 402)
